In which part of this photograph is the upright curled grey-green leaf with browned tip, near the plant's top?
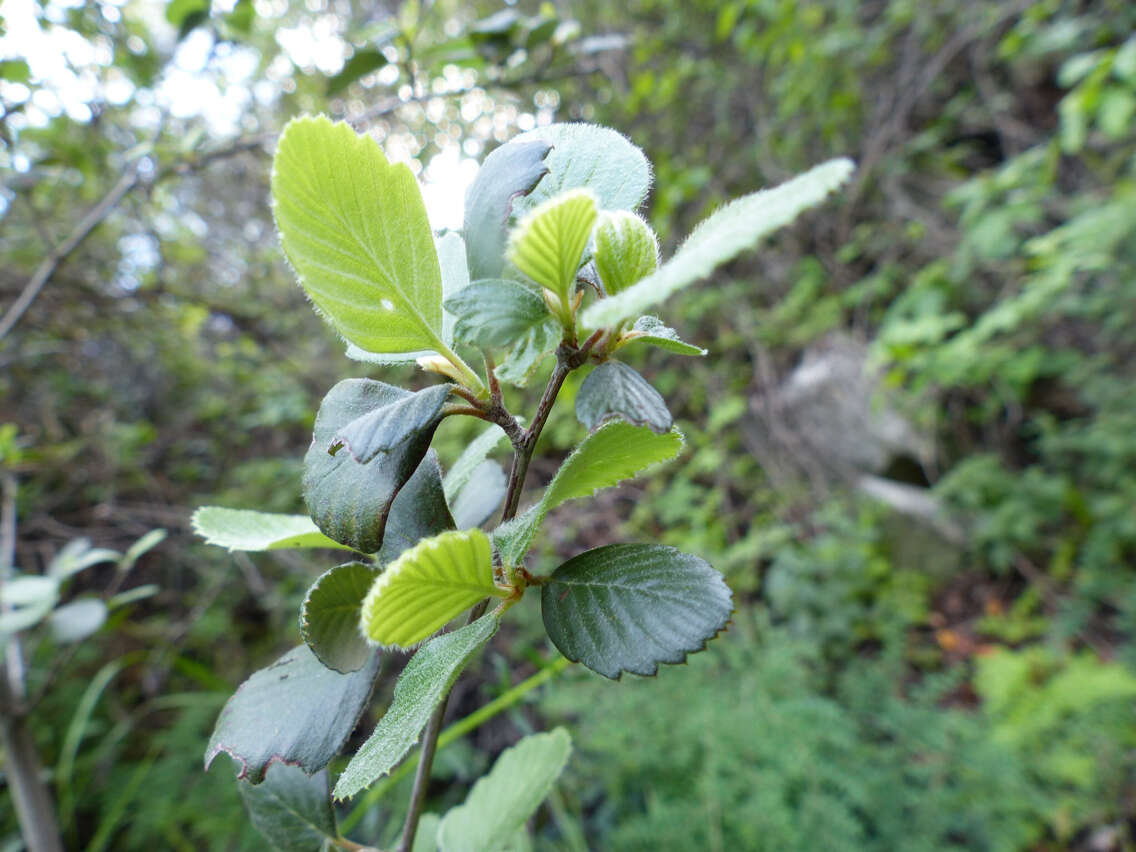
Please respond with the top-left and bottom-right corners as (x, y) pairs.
(463, 141), (551, 279)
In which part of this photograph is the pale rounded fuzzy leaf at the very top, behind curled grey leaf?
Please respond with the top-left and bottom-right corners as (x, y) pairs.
(512, 124), (651, 217)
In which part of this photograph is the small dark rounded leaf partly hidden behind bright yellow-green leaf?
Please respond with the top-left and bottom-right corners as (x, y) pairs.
(300, 562), (378, 674)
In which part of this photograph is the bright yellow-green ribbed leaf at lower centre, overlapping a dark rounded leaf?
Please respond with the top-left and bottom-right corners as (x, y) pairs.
(361, 529), (508, 649)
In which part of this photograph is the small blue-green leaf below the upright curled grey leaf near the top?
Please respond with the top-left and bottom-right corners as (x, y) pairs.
(445, 278), (550, 349)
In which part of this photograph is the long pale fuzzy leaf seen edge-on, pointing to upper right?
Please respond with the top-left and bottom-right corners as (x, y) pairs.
(580, 159), (853, 328)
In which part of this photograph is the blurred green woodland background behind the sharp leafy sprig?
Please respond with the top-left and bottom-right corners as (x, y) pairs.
(0, 0), (1136, 852)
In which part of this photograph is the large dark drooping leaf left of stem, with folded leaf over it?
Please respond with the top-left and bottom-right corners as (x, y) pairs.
(303, 378), (436, 553)
